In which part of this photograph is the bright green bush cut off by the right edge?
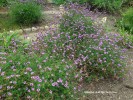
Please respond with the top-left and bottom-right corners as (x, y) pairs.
(120, 8), (133, 34)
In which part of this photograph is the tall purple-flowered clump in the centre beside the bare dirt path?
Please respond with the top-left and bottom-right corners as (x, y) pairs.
(57, 6), (125, 80)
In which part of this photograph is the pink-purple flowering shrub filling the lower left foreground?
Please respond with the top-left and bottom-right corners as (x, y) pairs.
(0, 33), (80, 100)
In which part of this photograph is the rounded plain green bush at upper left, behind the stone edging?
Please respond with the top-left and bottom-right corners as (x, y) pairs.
(10, 2), (41, 25)
